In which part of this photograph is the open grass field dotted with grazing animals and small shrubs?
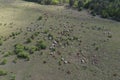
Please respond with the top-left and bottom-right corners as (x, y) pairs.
(0, 0), (120, 80)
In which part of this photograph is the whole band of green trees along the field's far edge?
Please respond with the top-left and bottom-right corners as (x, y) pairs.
(23, 0), (120, 21)
